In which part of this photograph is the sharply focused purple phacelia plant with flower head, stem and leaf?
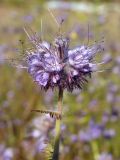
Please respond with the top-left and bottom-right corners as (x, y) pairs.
(9, 13), (106, 160)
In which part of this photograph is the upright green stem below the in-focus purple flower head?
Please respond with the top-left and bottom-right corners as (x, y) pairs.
(52, 88), (63, 160)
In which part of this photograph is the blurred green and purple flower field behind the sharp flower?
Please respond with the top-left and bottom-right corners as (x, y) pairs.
(0, 0), (120, 160)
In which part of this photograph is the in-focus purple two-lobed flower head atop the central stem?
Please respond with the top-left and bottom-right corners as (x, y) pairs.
(22, 28), (103, 91)
